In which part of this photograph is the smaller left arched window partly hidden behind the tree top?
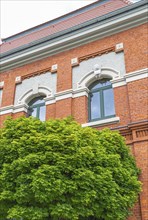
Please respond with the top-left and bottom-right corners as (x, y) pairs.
(28, 96), (46, 121)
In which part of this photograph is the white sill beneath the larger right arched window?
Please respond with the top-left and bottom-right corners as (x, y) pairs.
(82, 117), (120, 127)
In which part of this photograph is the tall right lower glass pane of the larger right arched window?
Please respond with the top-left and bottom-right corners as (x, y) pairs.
(103, 88), (115, 117)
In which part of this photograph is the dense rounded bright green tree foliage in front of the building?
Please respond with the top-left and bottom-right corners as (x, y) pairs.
(0, 117), (140, 220)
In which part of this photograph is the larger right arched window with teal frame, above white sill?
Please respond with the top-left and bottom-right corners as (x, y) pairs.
(88, 79), (115, 121)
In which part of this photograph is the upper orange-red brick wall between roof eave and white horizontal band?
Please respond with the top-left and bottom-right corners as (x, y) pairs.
(1, 24), (147, 106)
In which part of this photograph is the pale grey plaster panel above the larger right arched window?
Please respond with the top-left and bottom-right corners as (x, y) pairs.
(72, 52), (126, 89)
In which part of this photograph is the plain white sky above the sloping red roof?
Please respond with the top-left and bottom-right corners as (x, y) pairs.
(0, 0), (139, 38)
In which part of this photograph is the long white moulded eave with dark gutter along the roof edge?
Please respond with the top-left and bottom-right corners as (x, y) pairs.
(0, 1), (147, 72)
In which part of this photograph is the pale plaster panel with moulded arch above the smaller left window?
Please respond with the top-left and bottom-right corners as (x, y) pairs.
(14, 72), (57, 105)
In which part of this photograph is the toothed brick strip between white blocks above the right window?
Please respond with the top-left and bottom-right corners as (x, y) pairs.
(78, 46), (115, 63)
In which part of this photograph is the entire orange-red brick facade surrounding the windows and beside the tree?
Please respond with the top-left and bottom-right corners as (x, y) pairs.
(0, 1), (148, 220)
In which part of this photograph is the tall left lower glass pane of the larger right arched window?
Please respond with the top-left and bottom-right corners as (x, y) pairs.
(91, 92), (101, 120)
